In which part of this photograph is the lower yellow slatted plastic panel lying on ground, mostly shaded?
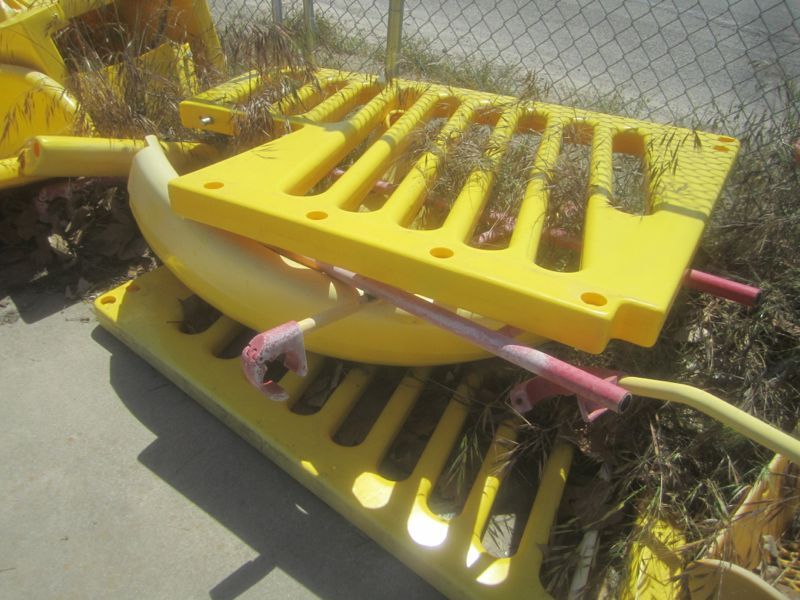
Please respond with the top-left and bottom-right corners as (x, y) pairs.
(95, 268), (572, 598)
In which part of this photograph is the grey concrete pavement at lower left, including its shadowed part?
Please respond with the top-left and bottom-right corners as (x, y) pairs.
(0, 292), (440, 600)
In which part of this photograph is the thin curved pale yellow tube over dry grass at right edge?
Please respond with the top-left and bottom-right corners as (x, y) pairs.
(619, 377), (800, 465)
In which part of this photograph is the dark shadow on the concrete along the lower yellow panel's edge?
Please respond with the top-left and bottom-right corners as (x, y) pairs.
(92, 327), (441, 600)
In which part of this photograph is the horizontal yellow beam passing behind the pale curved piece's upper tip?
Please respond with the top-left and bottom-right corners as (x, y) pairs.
(19, 135), (219, 177)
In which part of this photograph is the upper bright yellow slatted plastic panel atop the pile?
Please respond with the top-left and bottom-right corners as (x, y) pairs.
(170, 71), (738, 352)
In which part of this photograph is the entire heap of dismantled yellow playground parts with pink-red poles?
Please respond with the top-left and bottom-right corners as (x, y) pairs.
(0, 0), (800, 598)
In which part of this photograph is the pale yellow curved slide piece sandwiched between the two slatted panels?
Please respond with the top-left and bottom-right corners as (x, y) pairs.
(128, 137), (535, 365)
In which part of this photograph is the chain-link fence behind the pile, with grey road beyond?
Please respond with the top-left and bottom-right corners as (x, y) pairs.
(211, 0), (800, 134)
